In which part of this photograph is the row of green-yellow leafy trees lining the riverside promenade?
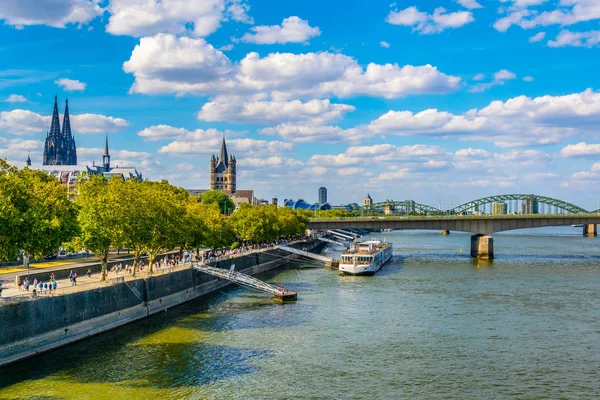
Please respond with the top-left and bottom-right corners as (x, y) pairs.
(0, 160), (308, 279)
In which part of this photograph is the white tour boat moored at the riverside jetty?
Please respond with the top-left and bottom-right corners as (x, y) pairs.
(340, 240), (392, 275)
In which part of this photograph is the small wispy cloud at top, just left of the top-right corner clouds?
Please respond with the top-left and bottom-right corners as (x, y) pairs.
(385, 6), (475, 34)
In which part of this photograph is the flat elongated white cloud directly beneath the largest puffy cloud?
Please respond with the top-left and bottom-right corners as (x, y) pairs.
(198, 96), (355, 124)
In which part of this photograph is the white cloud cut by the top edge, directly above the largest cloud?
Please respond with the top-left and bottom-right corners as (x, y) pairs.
(106, 0), (253, 37)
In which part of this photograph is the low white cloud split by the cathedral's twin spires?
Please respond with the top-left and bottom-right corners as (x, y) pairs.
(0, 109), (129, 135)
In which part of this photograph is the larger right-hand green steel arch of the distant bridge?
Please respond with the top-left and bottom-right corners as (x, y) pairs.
(449, 194), (590, 214)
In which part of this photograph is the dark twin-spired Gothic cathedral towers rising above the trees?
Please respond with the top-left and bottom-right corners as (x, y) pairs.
(43, 96), (77, 165)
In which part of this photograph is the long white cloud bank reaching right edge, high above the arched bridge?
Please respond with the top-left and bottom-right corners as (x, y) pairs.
(362, 89), (600, 148)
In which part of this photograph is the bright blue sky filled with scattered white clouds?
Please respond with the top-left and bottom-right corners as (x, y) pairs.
(0, 0), (600, 209)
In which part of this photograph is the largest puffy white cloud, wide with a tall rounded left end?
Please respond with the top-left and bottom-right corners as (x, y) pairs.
(123, 34), (461, 98)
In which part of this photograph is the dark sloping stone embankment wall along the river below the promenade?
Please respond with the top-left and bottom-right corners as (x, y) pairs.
(0, 241), (323, 366)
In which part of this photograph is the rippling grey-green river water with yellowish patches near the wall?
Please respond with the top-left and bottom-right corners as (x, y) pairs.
(0, 227), (600, 400)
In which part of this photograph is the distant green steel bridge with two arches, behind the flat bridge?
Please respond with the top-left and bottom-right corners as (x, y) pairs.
(359, 194), (600, 215)
